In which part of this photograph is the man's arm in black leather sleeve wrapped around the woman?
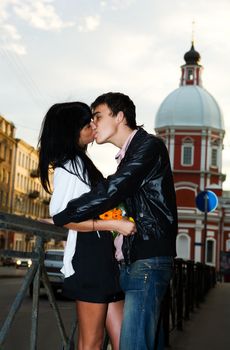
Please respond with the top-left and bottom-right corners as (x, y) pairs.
(53, 135), (163, 226)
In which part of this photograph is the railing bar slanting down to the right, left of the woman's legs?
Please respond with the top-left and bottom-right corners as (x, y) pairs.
(42, 268), (68, 348)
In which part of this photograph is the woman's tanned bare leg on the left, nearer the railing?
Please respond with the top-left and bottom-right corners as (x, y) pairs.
(76, 301), (108, 350)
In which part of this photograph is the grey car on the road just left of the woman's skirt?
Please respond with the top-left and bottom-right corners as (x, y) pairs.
(30, 249), (64, 296)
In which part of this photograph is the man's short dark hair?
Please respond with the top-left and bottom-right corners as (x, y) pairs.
(91, 92), (137, 130)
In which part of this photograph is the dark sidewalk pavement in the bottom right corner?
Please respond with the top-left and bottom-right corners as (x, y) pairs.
(170, 283), (230, 350)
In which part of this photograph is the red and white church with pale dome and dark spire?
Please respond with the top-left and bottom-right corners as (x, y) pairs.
(155, 42), (230, 270)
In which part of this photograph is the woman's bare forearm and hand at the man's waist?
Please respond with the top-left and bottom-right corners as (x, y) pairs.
(65, 219), (136, 236)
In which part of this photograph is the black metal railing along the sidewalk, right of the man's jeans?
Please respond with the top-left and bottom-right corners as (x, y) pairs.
(163, 259), (216, 346)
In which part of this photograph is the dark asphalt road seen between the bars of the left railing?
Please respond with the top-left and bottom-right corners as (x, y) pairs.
(0, 266), (75, 350)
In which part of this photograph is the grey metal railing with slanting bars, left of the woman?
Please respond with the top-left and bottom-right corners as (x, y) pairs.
(0, 213), (76, 350)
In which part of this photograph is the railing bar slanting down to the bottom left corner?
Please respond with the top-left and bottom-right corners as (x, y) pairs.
(0, 262), (38, 345)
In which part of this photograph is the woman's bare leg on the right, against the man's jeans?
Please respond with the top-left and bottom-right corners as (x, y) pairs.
(106, 300), (124, 350)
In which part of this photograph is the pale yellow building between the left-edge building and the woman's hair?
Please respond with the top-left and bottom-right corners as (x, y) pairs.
(11, 139), (50, 251)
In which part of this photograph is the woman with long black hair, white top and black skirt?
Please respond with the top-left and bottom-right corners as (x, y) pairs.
(39, 102), (135, 350)
